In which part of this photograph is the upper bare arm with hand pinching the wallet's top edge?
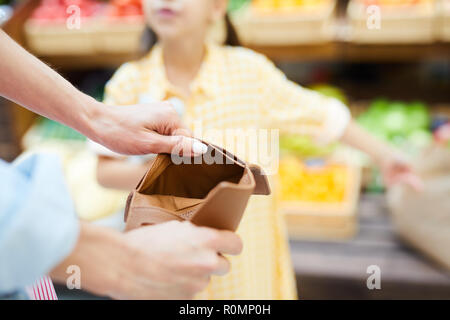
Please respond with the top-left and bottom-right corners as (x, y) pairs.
(0, 30), (206, 154)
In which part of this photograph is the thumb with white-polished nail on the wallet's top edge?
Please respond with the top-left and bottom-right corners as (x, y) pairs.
(149, 134), (208, 157)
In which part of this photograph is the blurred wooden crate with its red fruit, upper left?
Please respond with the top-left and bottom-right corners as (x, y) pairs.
(25, 0), (145, 56)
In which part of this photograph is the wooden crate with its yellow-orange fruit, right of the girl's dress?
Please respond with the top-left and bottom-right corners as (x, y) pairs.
(278, 156), (361, 240)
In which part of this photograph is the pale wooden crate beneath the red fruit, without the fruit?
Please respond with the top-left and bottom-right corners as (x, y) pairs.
(25, 18), (145, 56)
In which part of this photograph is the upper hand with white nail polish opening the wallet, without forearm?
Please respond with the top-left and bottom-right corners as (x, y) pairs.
(92, 102), (207, 156)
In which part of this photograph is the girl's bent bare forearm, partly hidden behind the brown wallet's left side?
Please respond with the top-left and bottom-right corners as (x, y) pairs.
(97, 157), (150, 191)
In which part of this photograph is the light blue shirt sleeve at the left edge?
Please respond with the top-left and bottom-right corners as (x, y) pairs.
(0, 154), (79, 293)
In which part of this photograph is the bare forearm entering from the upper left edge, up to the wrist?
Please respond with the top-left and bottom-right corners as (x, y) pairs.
(0, 30), (100, 136)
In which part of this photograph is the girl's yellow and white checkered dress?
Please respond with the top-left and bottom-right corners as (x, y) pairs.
(105, 44), (350, 299)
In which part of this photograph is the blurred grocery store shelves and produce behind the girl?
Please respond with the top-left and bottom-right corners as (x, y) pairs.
(0, 0), (450, 299)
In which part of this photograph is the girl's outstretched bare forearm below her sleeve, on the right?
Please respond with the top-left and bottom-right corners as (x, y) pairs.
(341, 120), (396, 164)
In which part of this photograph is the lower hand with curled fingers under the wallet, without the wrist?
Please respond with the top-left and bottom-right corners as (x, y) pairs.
(114, 222), (242, 299)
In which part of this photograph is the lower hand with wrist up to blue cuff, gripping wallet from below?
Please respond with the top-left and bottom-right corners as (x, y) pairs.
(51, 221), (242, 299)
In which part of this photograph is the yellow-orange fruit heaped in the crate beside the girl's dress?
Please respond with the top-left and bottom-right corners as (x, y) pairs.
(279, 156), (349, 203)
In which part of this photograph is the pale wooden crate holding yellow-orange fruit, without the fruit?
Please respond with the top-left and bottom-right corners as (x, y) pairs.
(279, 166), (361, 240)
